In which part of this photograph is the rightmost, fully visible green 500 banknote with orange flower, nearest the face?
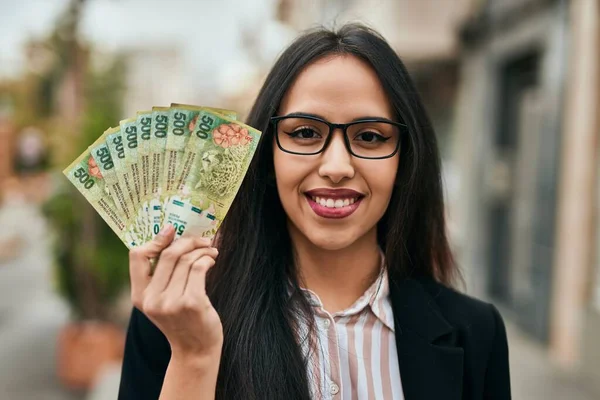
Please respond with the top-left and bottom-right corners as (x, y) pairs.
(165, 110), (260, 237)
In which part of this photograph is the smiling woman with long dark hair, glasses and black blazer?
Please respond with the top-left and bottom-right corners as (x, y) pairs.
(120, 25), (510, 400)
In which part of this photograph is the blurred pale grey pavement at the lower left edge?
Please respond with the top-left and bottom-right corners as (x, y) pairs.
(0, 202), (84, 400)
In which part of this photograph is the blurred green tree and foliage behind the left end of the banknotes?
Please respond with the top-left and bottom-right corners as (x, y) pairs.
(40, 0), (128, 320)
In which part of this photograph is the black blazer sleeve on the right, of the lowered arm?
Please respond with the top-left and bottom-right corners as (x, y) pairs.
(483, 306), (511, 400)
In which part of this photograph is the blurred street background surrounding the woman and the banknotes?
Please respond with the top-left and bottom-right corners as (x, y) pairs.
(0, 0), (600, 400)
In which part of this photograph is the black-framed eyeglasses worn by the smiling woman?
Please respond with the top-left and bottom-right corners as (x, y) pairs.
(271, 114), (407, 160)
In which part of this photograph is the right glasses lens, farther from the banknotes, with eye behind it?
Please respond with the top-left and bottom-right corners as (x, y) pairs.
(346, 122), (400, 158)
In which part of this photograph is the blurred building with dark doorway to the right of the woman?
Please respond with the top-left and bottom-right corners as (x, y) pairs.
(452, 0), (600, 388)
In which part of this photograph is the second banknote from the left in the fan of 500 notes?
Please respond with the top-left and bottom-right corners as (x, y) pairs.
(89, 128), (133, 222)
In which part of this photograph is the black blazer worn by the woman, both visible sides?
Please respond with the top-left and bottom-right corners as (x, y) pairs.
(119, 278), (511, 400)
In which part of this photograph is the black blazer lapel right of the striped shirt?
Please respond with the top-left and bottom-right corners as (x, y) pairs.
(390, 279), (463, 400)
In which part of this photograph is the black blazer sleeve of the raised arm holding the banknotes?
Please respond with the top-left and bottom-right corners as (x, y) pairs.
(118, 308), (171, 400)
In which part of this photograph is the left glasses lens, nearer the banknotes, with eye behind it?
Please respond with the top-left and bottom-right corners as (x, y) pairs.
(277, 117), (329, 154)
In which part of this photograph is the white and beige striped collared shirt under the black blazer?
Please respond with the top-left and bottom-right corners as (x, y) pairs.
(299, 269), (404, 400)
